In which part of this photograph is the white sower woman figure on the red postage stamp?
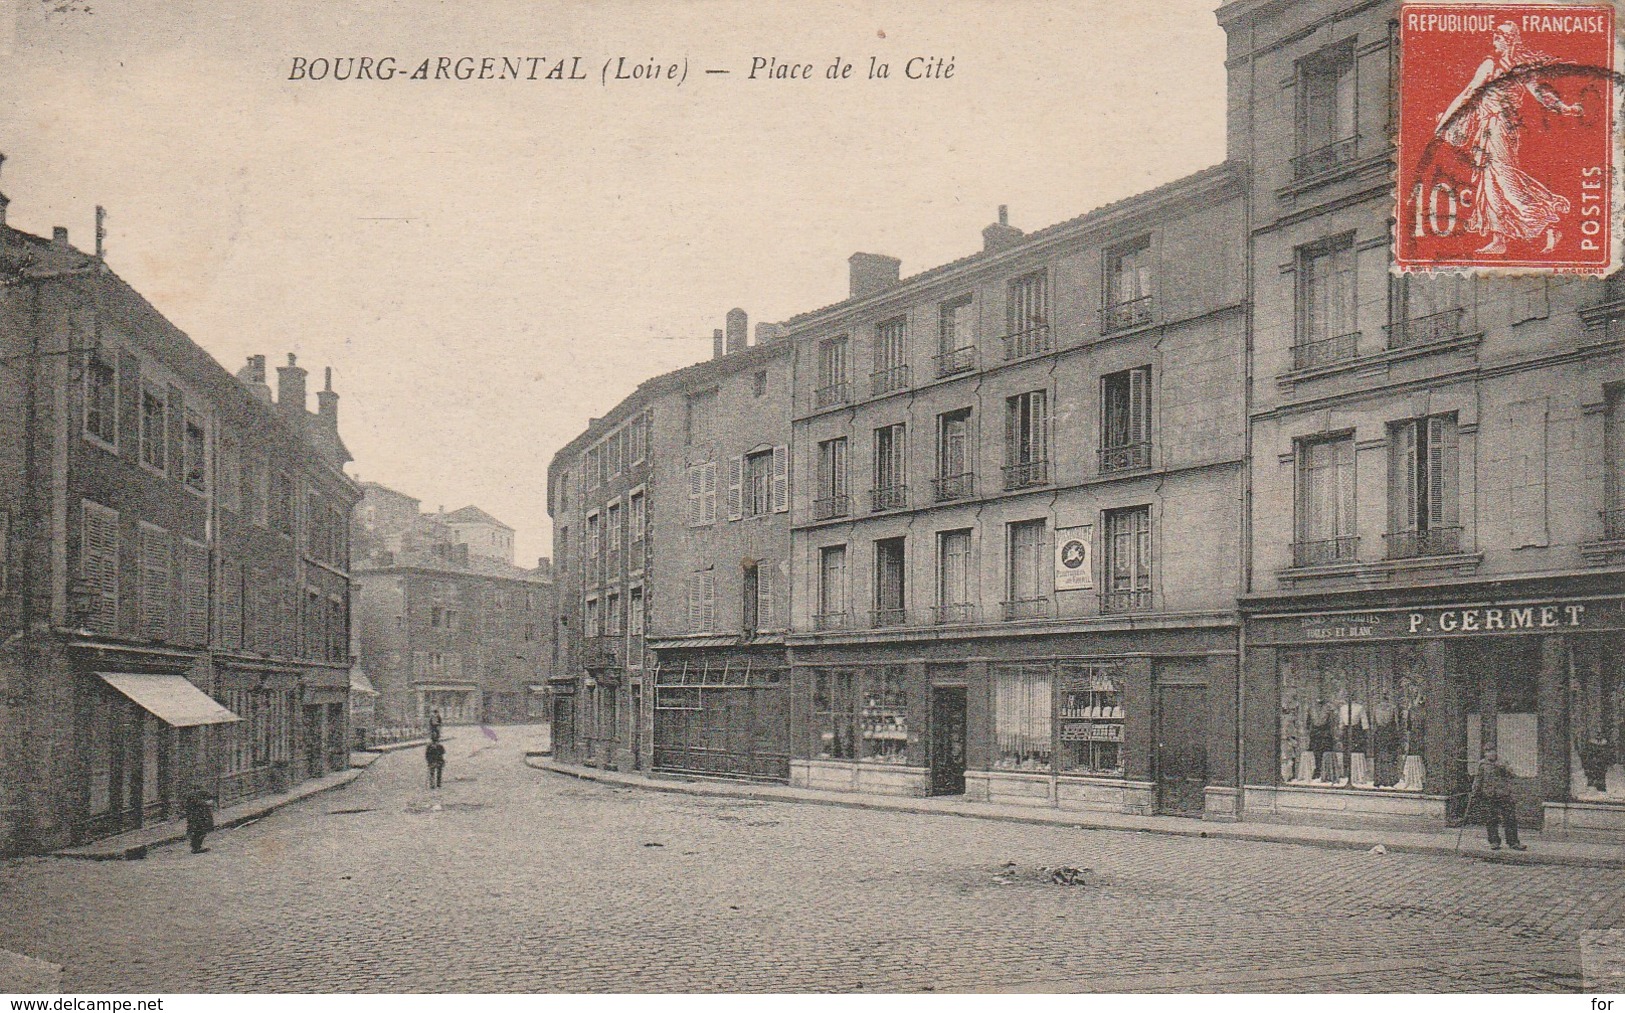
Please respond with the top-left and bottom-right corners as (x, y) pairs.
(1435, 21), (1583, 254)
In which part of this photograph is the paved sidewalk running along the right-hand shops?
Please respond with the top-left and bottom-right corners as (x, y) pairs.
(525, 751), (1625, 868)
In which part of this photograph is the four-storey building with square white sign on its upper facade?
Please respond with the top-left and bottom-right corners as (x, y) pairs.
(787, 184), (1246, 815)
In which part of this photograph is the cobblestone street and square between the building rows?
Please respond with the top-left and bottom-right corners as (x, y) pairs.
(0, 728), (1625, 992)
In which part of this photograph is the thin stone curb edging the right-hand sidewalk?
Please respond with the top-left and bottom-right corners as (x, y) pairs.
(525, 753), (1625, 868)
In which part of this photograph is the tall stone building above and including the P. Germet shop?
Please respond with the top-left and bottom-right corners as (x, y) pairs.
(1219, 0), (1625, 837)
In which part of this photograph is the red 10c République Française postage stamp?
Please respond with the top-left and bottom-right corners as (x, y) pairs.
(1394, 3), (1619, 275)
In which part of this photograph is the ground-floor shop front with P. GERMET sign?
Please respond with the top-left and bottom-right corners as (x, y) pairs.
(1245, 585), (1625, 837)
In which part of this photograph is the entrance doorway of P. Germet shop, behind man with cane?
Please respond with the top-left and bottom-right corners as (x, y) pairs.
(1456, 636), (1545, 828)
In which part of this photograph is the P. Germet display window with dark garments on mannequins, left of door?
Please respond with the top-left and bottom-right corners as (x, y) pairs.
(1281, 646), (1427, 792)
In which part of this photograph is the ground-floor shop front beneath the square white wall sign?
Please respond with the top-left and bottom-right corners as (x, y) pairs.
(791, 626), (1237, 820)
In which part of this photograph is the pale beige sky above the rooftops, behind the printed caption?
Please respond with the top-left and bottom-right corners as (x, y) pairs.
(0, 0), (1224, 561)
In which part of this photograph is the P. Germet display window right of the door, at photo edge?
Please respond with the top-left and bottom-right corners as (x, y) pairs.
(1568, 641), (1625, 802)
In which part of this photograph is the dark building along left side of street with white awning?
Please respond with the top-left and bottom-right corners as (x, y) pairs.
(0, 204), (359, 852)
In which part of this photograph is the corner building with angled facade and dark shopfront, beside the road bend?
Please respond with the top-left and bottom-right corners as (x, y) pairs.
(549, 309), (790, 780)
